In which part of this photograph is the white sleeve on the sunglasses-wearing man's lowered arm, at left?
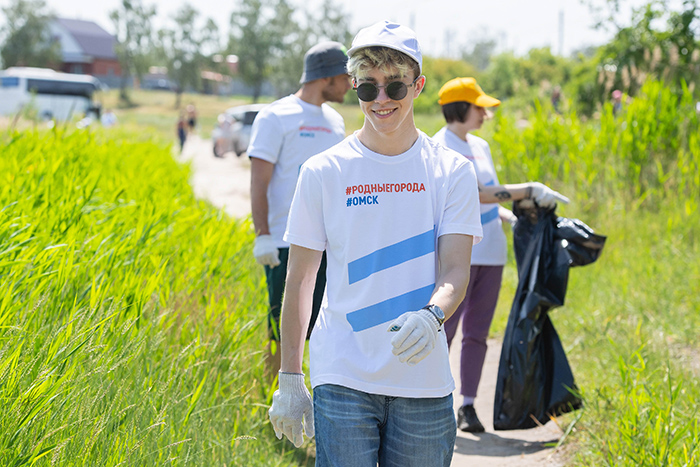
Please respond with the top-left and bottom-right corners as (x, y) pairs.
(284, 164), (327, 251)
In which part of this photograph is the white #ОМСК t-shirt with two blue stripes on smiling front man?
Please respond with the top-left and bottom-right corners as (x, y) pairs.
(285, 133), (481, 397)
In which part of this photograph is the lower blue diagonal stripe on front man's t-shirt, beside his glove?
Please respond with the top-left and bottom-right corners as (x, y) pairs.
(346, 284), (435, 332)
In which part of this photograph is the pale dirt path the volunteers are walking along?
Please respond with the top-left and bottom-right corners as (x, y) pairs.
(179, 135), (564, 467)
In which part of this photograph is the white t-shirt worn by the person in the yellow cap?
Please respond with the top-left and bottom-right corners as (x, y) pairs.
(433, 127), (508, 266)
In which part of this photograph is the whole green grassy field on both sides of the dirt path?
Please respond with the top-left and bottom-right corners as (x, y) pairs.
(0, 83), (700, 467)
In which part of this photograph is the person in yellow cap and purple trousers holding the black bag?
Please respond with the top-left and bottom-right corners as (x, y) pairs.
(433, 78), (569, 433)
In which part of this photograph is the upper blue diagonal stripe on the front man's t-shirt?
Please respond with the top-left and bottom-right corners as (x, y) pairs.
(348, 228), (435, 284)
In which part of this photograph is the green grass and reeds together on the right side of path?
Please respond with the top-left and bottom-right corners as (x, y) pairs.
(485, 82), (700, 467)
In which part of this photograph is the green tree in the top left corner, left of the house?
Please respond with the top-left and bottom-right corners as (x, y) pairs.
(0, 0), (61, 67)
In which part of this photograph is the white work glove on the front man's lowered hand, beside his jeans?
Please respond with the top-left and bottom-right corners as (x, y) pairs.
(268, 371), (314, 447)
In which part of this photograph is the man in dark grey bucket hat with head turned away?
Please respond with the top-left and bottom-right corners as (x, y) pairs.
(248, 42), (350, 377)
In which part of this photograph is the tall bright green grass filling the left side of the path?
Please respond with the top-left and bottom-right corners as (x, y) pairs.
(0, 129), (307, 466)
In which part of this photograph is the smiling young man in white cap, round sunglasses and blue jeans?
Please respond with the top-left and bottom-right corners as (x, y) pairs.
(270, 21), (481, 467)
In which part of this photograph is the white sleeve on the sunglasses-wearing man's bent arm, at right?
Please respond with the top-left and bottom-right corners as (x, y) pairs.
(438, 159), (483, 244)
